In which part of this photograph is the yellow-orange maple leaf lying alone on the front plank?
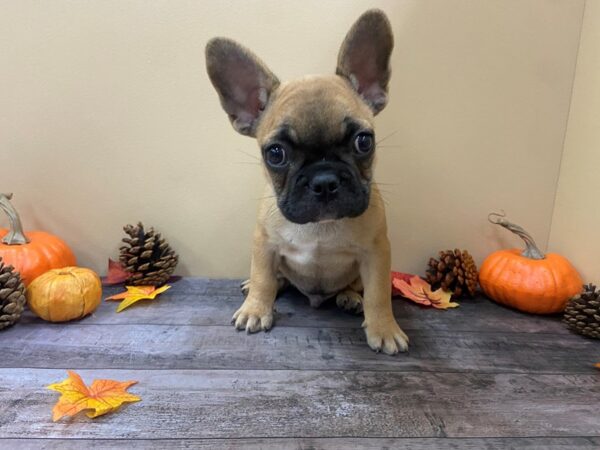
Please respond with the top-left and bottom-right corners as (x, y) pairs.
(46, 370), (141, 422)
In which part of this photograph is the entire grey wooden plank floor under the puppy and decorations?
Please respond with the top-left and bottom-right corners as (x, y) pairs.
(0, 279), (600, 450)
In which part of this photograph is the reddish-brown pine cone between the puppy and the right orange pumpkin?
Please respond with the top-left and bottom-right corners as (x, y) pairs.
(426, 249), (478, 297)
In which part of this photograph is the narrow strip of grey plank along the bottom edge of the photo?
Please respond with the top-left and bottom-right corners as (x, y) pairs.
(0, 437), (600, 450)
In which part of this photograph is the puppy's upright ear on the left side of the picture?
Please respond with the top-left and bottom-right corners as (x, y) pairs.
(206, 38), (279, 136)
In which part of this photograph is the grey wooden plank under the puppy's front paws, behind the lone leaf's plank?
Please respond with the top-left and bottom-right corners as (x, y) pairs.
(0, 323), (600, 373)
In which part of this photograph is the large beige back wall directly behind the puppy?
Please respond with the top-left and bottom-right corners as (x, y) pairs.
(0, 0), (583, 277)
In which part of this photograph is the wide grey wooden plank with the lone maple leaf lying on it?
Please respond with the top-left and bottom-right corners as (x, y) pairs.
(0, 369), (600, 439)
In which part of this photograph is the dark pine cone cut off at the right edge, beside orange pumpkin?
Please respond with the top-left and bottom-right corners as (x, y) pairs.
(563, 283), (600, 339)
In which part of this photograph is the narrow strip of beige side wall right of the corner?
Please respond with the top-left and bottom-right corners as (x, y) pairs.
(549, 0), (600, 283)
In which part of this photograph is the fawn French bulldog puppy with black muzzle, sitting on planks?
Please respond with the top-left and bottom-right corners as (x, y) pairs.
(206, 10), (408, 354)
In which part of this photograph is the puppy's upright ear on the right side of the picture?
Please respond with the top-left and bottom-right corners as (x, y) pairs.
(336, 9), (394, 114)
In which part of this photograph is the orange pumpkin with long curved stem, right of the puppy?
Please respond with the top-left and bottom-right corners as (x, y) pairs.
(479, 213), (583, 314)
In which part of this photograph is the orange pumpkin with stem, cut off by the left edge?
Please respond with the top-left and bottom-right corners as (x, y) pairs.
(0, 194), (77, 286)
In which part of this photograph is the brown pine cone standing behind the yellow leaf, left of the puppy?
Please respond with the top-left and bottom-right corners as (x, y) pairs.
(119, 222), (179, 286)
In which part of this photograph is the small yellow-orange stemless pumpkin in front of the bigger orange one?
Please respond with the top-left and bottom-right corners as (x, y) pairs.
(25, 267), (102, 322)
